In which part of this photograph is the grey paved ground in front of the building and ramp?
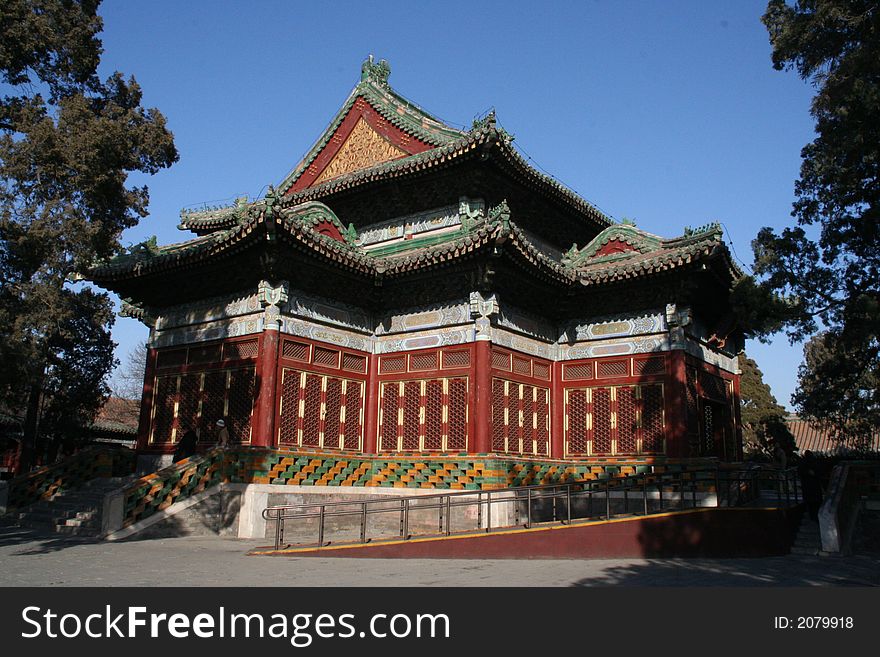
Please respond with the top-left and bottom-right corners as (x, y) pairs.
(0, 527), (880, 587)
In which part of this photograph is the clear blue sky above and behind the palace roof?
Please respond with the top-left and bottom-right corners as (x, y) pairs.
(99, 0), (813, 406)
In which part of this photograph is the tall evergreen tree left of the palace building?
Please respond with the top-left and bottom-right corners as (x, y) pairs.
(0, 0), (177, 467)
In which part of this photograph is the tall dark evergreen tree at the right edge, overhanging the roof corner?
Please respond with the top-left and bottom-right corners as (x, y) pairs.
(740, 0), (880, 439)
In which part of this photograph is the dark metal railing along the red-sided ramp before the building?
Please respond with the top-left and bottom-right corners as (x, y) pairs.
(263, 468), (800, 550)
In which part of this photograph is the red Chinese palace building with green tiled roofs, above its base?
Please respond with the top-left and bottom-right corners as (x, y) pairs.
(89, 58), (742, 474)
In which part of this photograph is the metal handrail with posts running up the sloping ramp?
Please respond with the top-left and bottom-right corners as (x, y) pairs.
(262, 468), (799, 550)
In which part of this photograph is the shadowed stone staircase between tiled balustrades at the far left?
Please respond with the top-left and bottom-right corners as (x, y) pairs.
(10, 476), (136, 537)
